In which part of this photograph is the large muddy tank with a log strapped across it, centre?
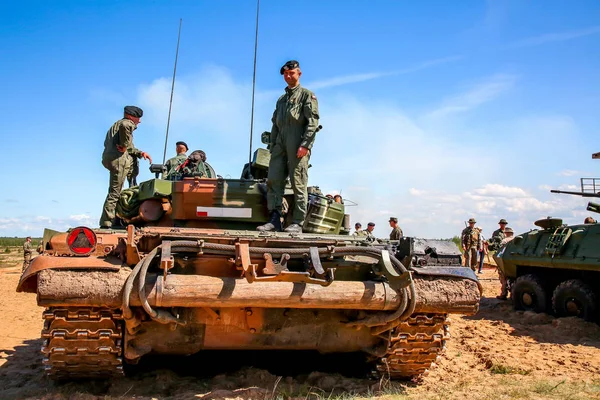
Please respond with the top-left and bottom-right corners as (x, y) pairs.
(17, 139), (481, 380)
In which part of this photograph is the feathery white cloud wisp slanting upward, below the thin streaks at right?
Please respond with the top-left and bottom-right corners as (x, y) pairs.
(426, 74), (517, 118)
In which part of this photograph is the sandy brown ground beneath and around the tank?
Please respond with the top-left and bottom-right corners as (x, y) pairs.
(0, 250), (600, 400)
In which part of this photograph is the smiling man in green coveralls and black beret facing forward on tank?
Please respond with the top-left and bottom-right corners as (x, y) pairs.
(256, 60), (319, 233)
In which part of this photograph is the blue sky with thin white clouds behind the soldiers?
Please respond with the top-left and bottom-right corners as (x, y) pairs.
(0, 0), (600, 237)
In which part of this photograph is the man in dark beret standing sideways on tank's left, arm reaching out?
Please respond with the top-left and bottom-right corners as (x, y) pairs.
(100, 106), (152, 228)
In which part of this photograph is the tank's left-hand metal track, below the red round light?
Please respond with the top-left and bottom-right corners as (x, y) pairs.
(42, 308), (123, 380)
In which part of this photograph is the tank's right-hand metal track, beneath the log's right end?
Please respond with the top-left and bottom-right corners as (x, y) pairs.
(376, 314), (450, 380)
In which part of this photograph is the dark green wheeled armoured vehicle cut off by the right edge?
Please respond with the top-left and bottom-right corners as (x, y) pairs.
(494, 159), (600, 322)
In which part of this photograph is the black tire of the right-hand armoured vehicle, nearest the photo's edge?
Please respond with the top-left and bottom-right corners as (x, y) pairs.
(552, 279), (598, 321)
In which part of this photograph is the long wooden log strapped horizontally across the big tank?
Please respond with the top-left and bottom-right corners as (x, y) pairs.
(38, 269), (479, 314)
